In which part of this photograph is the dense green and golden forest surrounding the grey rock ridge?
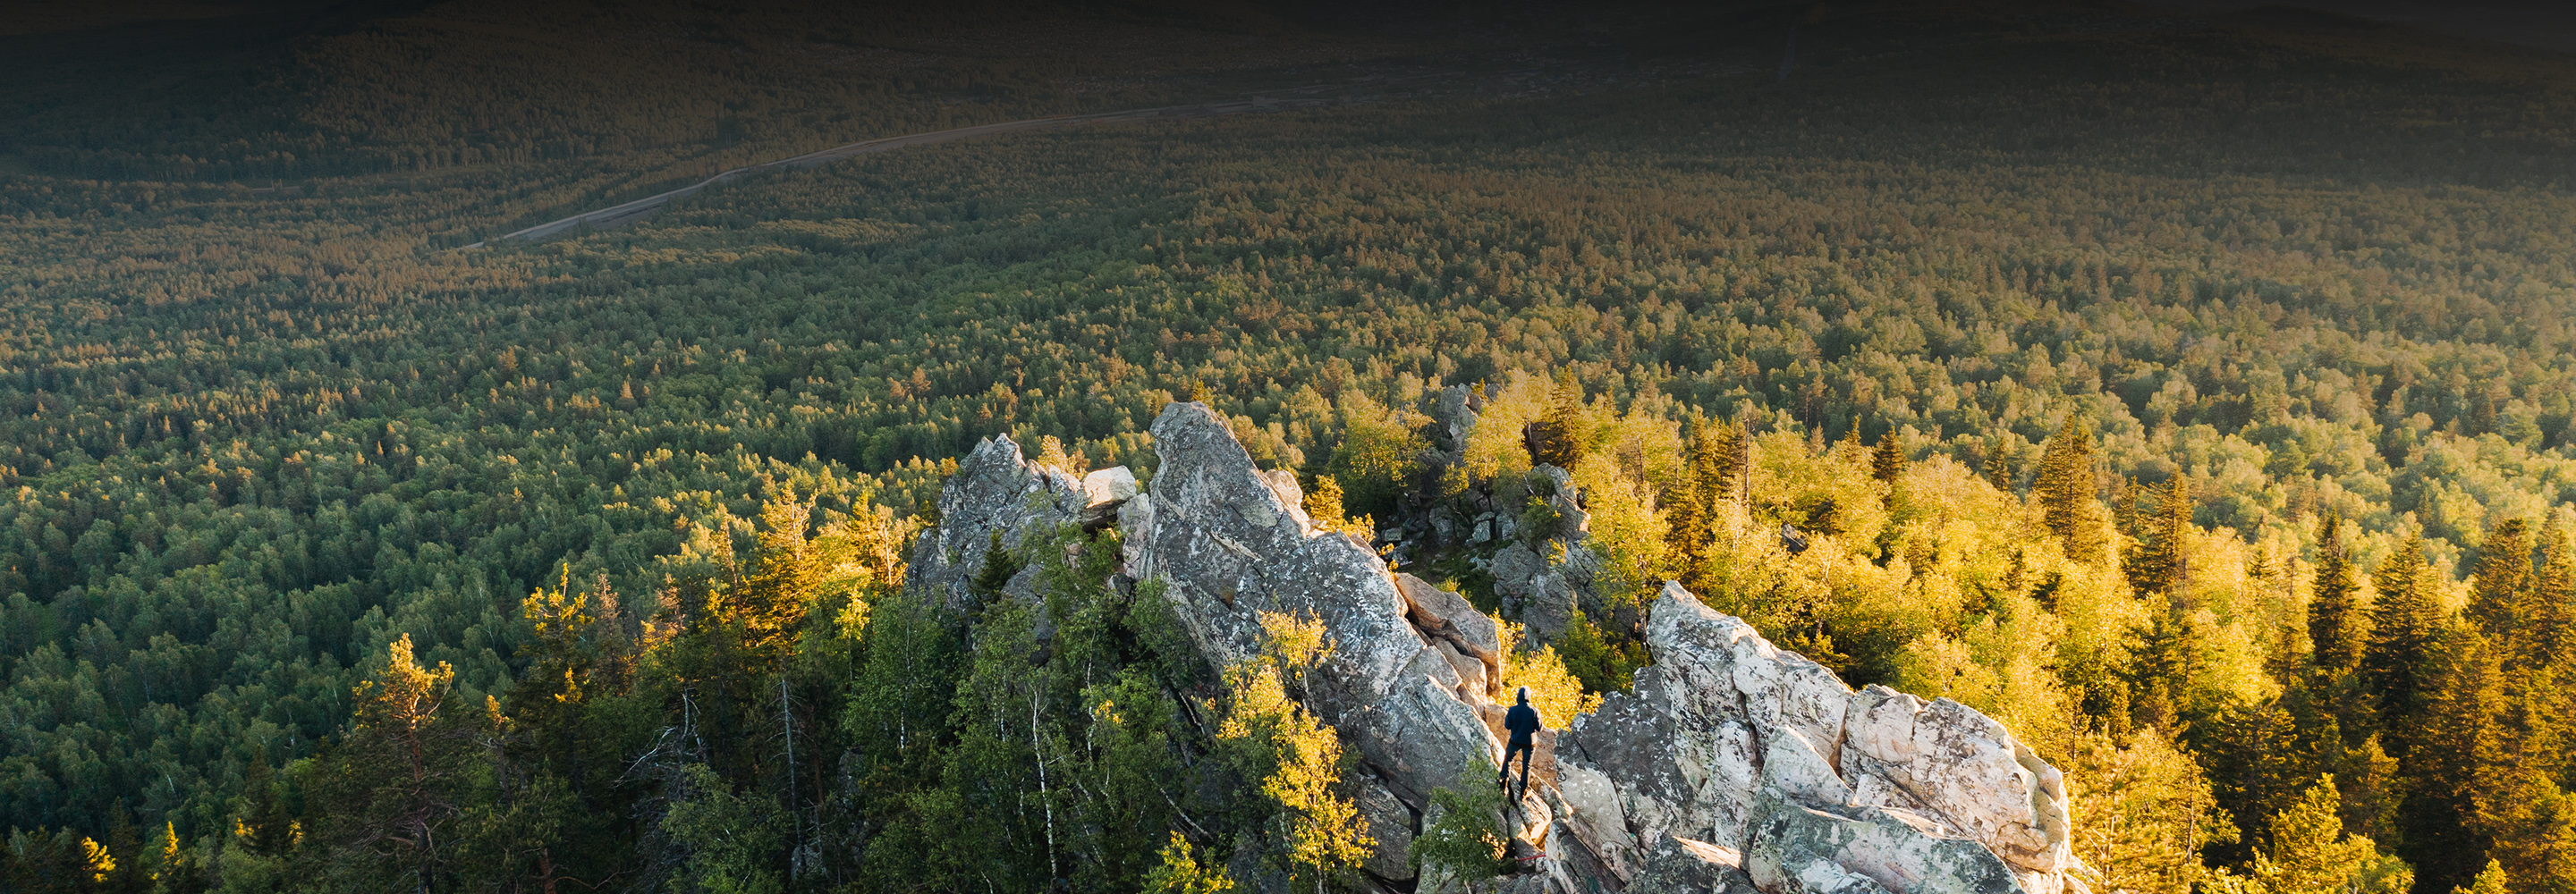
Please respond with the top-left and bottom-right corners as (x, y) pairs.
(0, 3), (2576, 894)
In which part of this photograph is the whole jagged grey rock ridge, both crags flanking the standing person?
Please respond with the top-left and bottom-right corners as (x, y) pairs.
(914, 404), (2081, 894)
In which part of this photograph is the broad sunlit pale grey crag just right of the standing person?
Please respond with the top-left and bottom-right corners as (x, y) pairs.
(1556, 585), (2073, 894)
